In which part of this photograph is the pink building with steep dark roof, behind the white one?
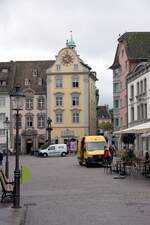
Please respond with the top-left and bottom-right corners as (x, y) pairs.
(110, 32), (150, 131)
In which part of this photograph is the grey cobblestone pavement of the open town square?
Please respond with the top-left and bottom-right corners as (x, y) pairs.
(2, 156), (150, 225)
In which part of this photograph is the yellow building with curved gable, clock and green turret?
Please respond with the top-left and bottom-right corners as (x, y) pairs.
(47, 37), (97, 143)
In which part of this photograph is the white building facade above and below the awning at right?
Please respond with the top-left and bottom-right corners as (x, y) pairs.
(127, 62), (150, 155)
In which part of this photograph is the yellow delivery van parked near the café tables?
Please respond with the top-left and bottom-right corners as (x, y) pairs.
(77, 136), (106, 167)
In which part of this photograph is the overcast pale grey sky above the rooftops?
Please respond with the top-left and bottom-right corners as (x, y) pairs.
(0, 0), (150, 107)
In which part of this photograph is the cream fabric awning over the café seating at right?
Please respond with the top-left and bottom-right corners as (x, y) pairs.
(114, 122), (150, 135)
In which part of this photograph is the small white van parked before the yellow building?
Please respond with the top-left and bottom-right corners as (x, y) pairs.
(38, 144), (68, 157)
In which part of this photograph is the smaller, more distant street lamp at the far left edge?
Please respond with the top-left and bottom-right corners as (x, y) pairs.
(3, 117), (10, 178)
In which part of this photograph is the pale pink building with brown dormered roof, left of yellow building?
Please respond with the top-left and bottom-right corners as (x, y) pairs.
(11, 61), (53, 154)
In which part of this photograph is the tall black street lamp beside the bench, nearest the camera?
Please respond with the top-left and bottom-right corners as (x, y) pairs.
(10, 86), (25, 208)
